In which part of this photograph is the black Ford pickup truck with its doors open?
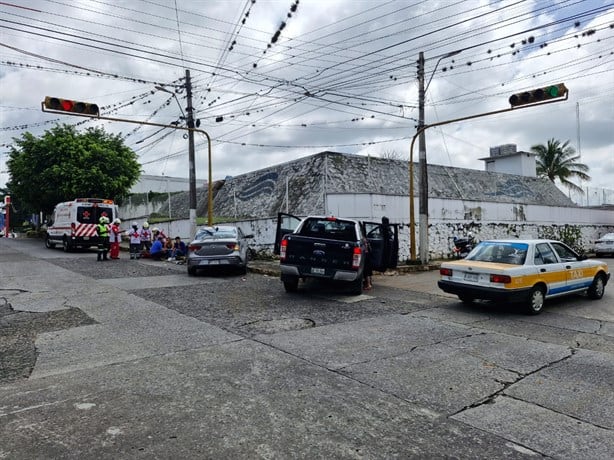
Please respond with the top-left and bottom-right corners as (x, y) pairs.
(275, 213), (399, 295)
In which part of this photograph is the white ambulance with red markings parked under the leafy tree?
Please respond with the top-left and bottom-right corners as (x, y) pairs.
(45, 198), (119, 252)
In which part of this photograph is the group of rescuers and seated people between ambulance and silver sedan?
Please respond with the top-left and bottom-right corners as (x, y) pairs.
(96, 216), (187, 261)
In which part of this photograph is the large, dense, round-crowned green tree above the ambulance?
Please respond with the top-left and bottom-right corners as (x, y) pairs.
(7, 125), (140, 214)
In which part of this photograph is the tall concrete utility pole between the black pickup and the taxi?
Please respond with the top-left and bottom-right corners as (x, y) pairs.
(418, 51), (429, 265)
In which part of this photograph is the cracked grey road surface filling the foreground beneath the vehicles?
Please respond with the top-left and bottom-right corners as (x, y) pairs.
(0, 239), (614, 459)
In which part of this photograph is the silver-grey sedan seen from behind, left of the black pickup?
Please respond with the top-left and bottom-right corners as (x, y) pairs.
(186, 225), (254, 275)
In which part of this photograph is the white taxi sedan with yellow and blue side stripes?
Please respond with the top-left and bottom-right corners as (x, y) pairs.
(438, 240), (610, 315)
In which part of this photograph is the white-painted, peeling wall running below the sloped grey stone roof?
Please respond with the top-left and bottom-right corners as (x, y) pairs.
(120, 194), (614, 262)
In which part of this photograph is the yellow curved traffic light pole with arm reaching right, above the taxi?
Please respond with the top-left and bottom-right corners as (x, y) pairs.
(409, 91), (569, 263)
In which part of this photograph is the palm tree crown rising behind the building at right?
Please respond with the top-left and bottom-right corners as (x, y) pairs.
(531, 139), (591, 192)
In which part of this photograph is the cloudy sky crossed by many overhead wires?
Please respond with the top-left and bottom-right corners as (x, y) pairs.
(0, 0), (614, 191)
